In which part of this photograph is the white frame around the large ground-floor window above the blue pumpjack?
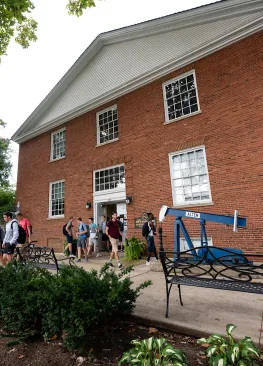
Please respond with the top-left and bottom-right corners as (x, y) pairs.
(169, 145), (213, 207)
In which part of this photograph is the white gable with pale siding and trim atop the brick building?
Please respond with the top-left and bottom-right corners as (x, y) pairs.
(12, 0), (263, 143)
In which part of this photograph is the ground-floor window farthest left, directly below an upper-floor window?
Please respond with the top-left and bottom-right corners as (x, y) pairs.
(49, 180), (65, 217)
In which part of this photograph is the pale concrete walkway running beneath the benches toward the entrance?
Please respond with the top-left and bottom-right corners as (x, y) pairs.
(72, 257), (263, 344)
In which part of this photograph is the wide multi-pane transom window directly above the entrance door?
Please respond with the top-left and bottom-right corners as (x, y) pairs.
(94, 165), (125, 192)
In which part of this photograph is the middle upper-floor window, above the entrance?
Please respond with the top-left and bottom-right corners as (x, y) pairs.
(97, 105), (119, 145)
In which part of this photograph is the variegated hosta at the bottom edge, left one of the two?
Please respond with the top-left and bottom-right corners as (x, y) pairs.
(119, 337), (187, 366)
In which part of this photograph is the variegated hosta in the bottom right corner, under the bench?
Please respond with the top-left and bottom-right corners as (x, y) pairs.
(197, 324), (260, 366)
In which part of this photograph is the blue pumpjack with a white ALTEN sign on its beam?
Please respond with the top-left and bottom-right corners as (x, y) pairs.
(159, 206), (246, 262)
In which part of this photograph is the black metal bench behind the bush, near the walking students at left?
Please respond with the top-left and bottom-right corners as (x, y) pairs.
(16, 244), (75, 272)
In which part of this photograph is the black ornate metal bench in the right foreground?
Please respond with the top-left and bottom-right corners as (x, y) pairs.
(160, 246), (263, 318)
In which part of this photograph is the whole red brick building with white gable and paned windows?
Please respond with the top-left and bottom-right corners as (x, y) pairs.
(13, 0), (263, 252)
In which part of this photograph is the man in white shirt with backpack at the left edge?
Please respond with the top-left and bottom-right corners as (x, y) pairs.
(2, 212), (19, 266)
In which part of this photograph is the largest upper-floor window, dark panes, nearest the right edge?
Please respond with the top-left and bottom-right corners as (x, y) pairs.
(163, 71), (200, 122)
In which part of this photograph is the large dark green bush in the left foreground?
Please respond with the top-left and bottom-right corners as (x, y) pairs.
(0, 264), (150, 349)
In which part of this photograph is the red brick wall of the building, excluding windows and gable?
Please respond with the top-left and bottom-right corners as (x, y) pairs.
(17, 32), (263, 252)
